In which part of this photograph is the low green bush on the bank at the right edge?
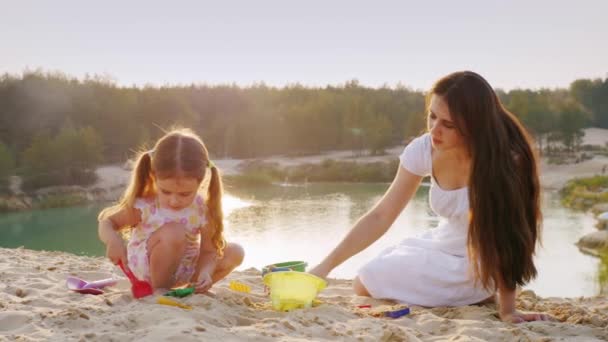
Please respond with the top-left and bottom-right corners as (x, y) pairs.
(560, 176), (608, 210)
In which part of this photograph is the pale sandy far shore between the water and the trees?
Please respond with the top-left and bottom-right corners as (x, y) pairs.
(0, 128), (608, 211)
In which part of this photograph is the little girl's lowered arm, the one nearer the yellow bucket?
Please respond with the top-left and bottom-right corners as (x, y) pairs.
(190, 224), (217, 293)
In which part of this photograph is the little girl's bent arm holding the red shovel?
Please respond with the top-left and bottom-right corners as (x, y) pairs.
(97, 208), (141, 267)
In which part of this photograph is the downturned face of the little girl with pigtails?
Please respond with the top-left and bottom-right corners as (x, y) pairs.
(156, 177), (200, 211)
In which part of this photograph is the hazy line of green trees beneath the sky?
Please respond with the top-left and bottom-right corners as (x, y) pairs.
(0, 71), (608, 189)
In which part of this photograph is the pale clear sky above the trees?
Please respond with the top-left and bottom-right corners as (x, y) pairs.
(0, 0), (608, 90)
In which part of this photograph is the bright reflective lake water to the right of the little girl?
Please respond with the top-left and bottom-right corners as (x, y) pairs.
(227, 184), (599, 297)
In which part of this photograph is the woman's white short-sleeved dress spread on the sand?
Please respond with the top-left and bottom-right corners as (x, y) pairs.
(359, 133), (492, 306)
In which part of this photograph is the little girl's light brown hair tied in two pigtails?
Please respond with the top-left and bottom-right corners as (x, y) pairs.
(98, 128), (226, 257)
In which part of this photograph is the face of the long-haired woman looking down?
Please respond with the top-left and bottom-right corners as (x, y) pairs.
(427, 94), (465, 150)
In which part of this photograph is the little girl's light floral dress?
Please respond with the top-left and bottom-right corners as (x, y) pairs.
(127, 194), (207, 284)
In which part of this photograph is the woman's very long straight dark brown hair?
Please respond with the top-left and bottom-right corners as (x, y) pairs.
(431, 71), (542, 289)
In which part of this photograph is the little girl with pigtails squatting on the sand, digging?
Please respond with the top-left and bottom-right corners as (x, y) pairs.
(99, 129), (244, 293)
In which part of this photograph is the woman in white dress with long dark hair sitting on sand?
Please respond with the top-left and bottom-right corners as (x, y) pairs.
(311, 71), (549, 323)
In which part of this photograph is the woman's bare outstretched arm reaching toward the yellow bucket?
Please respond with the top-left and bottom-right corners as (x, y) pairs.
(309, 166), (422, 278)
